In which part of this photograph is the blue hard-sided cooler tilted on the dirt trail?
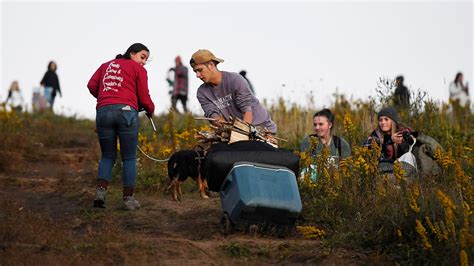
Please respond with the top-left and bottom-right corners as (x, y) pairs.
(220, 162), (302, 234)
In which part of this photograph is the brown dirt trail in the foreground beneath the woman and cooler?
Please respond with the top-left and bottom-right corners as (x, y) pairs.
(0, 137), (367, 265)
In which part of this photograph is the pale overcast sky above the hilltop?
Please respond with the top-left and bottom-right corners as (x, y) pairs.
(0, 1), (474, 118)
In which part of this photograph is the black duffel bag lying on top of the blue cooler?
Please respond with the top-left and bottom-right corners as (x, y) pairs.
(201, 140), (300, 192)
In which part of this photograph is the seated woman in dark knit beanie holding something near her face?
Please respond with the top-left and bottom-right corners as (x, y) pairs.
(363, 107), (412, 163)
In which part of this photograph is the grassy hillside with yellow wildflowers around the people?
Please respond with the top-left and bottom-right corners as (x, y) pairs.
(0, 89), (474, 265)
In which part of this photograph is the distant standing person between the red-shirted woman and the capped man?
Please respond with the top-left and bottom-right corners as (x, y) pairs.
(167, 56), (188, 113)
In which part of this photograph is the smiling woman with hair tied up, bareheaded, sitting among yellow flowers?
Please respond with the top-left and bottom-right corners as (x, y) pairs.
(300, 109), (351, 163)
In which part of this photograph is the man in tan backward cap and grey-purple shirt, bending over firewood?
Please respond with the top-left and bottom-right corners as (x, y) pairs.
(190, 50), (277, 133)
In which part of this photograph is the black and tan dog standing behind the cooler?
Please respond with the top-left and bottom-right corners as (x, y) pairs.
(168, 147), (209, 201)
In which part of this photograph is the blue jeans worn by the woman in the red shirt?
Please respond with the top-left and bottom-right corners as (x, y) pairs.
(96, 104), (138, 187)
